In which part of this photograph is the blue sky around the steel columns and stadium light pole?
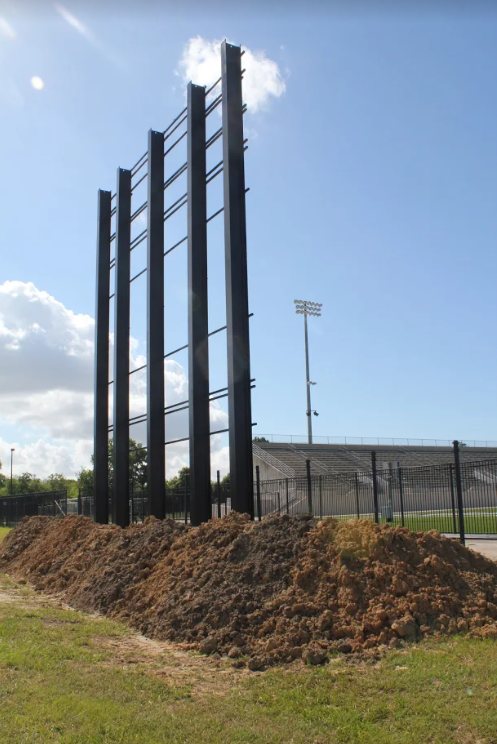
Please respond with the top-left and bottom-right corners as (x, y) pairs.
(0, 0), (497, 471)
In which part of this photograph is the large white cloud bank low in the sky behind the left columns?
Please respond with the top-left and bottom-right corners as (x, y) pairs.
(0, 281), (228, 477)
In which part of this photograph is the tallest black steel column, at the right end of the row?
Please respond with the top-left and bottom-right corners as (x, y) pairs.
(221, 41), (254, 518)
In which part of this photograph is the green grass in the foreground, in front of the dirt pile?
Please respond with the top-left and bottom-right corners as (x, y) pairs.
(0, 576), (497, 744)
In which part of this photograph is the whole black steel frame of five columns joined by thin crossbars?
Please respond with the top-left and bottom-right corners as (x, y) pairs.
(95, 42), (254, 527)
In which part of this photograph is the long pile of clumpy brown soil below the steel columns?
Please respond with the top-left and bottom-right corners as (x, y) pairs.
(0, 514), (497, 669)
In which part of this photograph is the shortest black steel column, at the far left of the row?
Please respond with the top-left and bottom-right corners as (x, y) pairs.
(93, 191), (111, 524)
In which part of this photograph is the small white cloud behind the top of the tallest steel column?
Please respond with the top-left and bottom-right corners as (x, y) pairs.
(177, 36), (286, 113)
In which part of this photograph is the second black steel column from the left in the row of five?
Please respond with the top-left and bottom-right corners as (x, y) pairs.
(112, 168), (131, 527)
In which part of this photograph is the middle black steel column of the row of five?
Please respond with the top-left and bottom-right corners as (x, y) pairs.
(147, 130), (166, 519)
